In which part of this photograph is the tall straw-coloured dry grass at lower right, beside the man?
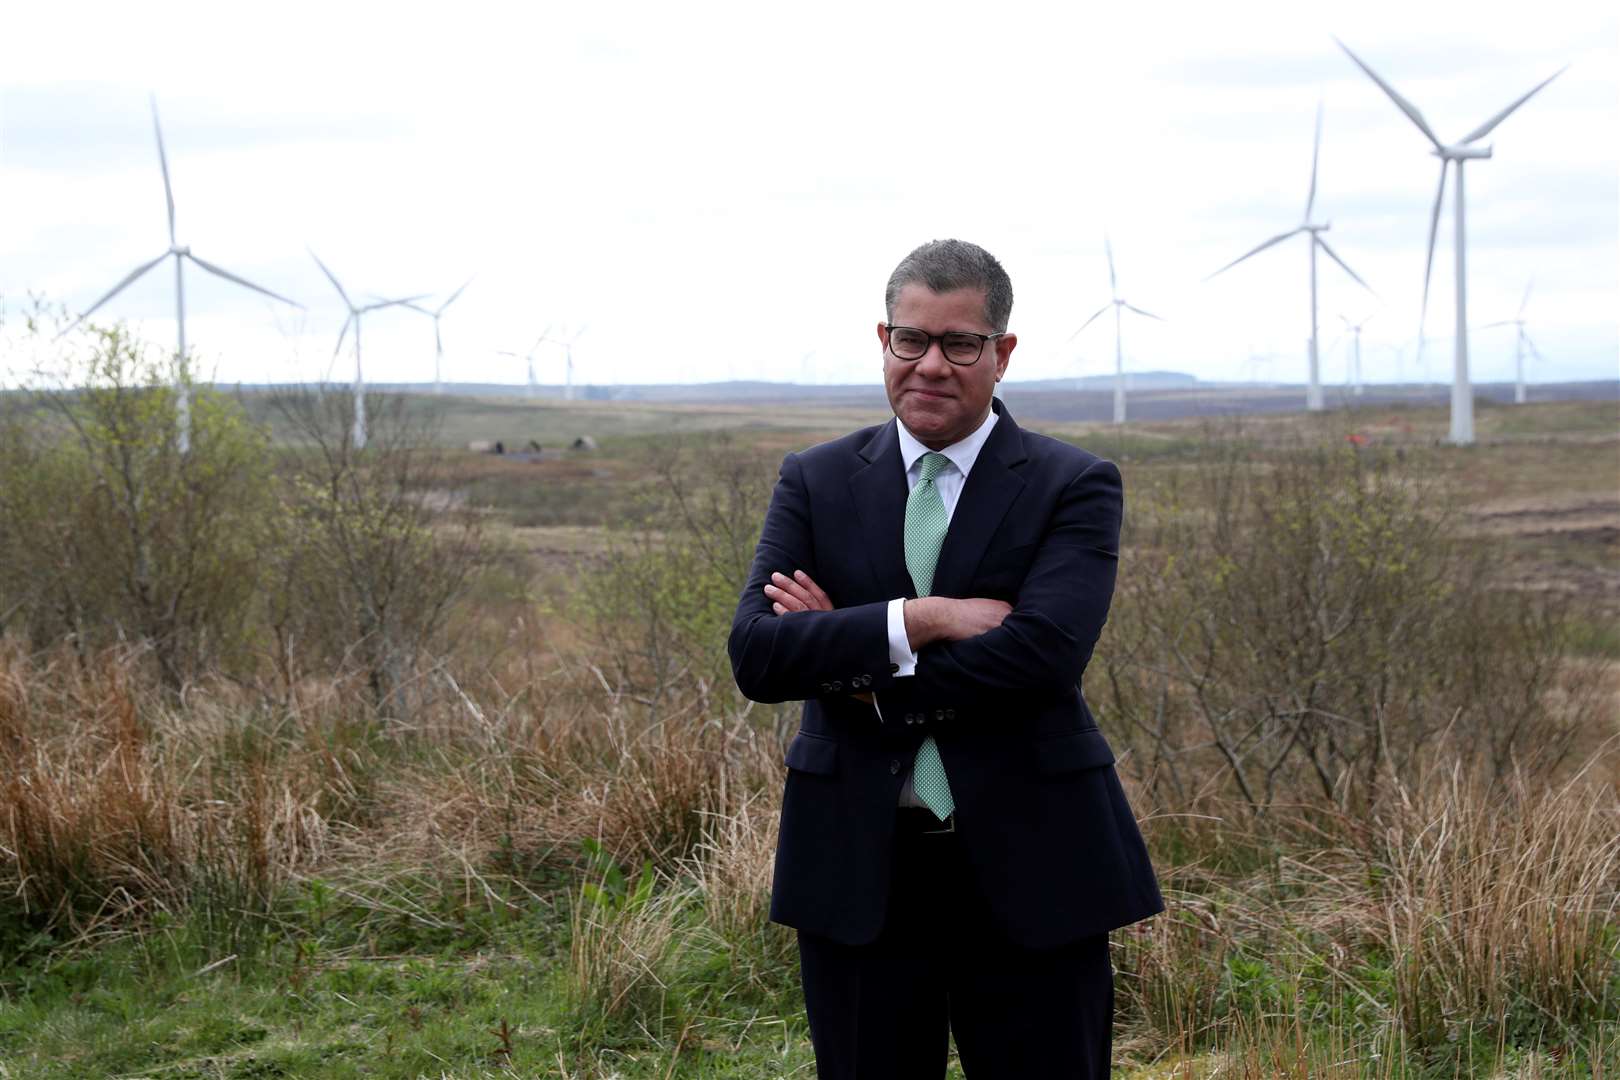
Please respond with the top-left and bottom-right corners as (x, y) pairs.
(1115, 746), (1620, 1075)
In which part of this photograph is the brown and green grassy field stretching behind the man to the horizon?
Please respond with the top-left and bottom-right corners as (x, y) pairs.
(0, 386), (1620, 1080)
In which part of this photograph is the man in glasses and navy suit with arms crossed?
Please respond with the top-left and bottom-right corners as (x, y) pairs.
(729, 240), (1163, 1080)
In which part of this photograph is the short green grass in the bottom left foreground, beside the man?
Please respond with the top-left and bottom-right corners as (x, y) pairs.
(0, 889), (812, 1080)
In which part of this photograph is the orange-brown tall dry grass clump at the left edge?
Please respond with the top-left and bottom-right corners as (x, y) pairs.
(0, 649), (327, 931)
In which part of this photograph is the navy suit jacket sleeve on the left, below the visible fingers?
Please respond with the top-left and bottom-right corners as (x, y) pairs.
(727, 453), (893, 703)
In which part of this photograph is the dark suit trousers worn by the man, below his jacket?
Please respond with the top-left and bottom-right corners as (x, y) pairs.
(799, 810), (1113, 1080)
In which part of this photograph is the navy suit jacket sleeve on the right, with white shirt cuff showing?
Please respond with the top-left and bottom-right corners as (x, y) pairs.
(880, 460), (1124, 709)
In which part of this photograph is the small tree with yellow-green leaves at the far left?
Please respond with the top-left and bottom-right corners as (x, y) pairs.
(0, 327), (269, 690)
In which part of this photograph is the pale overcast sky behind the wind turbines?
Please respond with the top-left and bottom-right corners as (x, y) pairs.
(0, 0), (1620, 384)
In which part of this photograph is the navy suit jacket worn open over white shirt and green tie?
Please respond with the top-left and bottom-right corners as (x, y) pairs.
(729, 402), (1163, 947)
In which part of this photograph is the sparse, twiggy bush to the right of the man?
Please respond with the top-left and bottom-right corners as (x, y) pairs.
(1092, 439), (1597, 813)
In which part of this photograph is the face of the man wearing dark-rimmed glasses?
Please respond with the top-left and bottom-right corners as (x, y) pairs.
(878, 283), (1017, 450)
